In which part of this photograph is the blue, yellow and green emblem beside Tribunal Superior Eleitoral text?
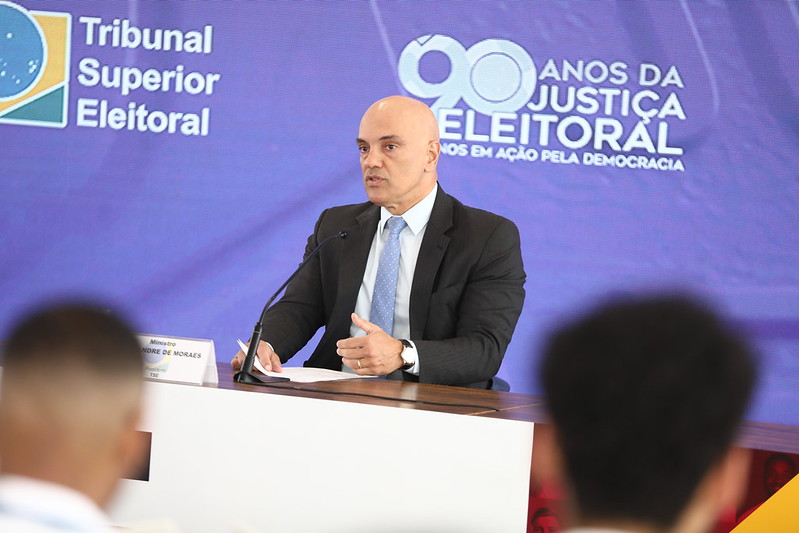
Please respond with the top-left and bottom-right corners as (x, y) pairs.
(0, 1), (72, 128)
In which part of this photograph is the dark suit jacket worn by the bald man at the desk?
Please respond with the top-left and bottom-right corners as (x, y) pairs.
(264, 186), (525, 388)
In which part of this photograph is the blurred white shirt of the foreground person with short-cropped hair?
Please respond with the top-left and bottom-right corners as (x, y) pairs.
(0, 475), (111, 533)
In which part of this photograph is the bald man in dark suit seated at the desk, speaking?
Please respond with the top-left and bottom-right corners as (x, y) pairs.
(232, 96), (525, 388)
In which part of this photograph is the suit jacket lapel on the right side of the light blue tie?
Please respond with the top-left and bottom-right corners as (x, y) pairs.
(410, 185), (452, 339)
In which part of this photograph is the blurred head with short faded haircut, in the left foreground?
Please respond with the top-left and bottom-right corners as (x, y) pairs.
(0, 303), (143, 508)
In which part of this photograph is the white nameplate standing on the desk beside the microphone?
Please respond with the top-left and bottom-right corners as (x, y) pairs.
(137, 334), (219, 385)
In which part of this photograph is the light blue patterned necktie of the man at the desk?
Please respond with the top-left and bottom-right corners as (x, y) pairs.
(369, 217), (408, 335)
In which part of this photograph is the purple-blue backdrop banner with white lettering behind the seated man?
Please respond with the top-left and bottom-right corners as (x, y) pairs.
(0, 0), (799, 424)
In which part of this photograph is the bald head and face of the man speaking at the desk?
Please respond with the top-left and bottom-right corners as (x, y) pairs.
(357, 98), (438, 215)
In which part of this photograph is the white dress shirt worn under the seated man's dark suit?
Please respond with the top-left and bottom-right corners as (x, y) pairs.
(342, 184), (438, 376)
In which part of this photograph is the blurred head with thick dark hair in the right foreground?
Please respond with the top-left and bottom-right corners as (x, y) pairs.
(540, 295), (757, 532)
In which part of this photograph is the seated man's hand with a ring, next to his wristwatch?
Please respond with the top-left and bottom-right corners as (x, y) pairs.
(336, 313), (404, 376)
